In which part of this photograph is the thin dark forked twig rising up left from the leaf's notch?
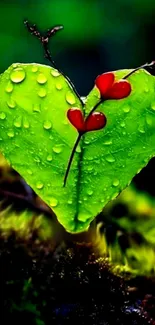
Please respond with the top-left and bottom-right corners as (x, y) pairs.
(24, 20), (84, 107)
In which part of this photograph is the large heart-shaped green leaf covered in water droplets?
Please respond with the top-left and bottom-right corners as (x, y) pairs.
(0, 64), (155, 232)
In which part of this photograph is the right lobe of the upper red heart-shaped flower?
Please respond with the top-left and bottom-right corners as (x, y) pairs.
(104, 79), (131, 99)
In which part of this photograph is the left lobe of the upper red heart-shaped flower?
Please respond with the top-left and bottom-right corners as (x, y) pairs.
(95, 72), (115, 97)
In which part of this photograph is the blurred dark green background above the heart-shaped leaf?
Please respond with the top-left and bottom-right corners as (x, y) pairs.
(0, 0), (155, 95)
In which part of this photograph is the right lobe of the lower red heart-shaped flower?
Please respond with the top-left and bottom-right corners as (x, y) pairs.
(85, 112), (106, 132)
